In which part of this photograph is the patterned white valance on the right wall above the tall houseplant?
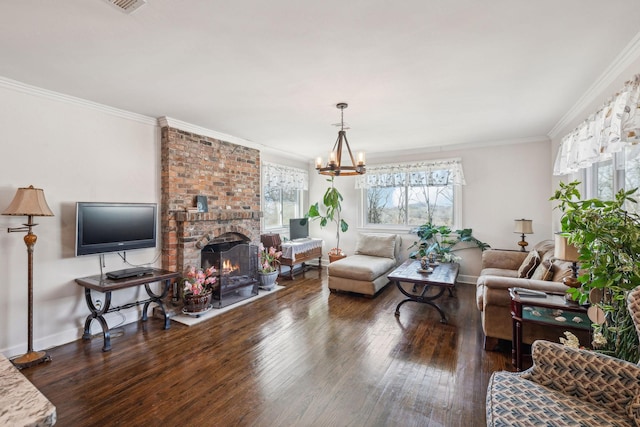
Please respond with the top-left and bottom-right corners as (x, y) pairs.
(553, 74), (640, 175)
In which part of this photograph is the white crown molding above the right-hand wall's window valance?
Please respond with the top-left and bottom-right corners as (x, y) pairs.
(548, 33), (640, 139)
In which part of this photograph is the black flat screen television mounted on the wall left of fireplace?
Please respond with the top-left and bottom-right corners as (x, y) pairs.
(76, 202), (158, 256)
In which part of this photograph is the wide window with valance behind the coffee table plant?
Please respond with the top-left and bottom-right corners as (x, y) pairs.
(356, 159), (464, 227)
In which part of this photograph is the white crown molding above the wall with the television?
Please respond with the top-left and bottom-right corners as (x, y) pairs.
(0, 76), (157, 126)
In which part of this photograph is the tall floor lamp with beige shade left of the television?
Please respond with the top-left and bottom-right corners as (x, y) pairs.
(2, 185), (53, 369)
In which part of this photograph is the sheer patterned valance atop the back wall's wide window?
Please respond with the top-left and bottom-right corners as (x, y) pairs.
(356, 159), (466, 188)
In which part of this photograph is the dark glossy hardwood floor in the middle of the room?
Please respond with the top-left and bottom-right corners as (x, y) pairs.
(22, 271), (513, 426)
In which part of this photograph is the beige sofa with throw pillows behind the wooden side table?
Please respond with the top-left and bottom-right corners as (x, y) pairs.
(476, 240), (571, 350)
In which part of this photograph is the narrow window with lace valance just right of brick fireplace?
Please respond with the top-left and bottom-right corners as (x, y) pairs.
(262, 162), (309, 232)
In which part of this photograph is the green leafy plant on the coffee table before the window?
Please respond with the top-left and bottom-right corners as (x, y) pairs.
(409, 223), (490, 262)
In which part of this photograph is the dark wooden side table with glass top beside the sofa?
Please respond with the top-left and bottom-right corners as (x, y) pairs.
(509, 288), (591, 371)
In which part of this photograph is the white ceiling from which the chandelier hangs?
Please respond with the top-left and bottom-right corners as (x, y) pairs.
(0, 0), (640, 159)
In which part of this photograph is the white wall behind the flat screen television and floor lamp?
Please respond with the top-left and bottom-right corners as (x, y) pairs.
(0, 82), (160, 356)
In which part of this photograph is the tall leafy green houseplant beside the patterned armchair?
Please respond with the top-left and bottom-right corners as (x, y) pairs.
(551, 181), (640, 363)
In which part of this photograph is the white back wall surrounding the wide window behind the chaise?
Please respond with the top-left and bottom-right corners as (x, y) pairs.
(309, 139), (552, 282)
